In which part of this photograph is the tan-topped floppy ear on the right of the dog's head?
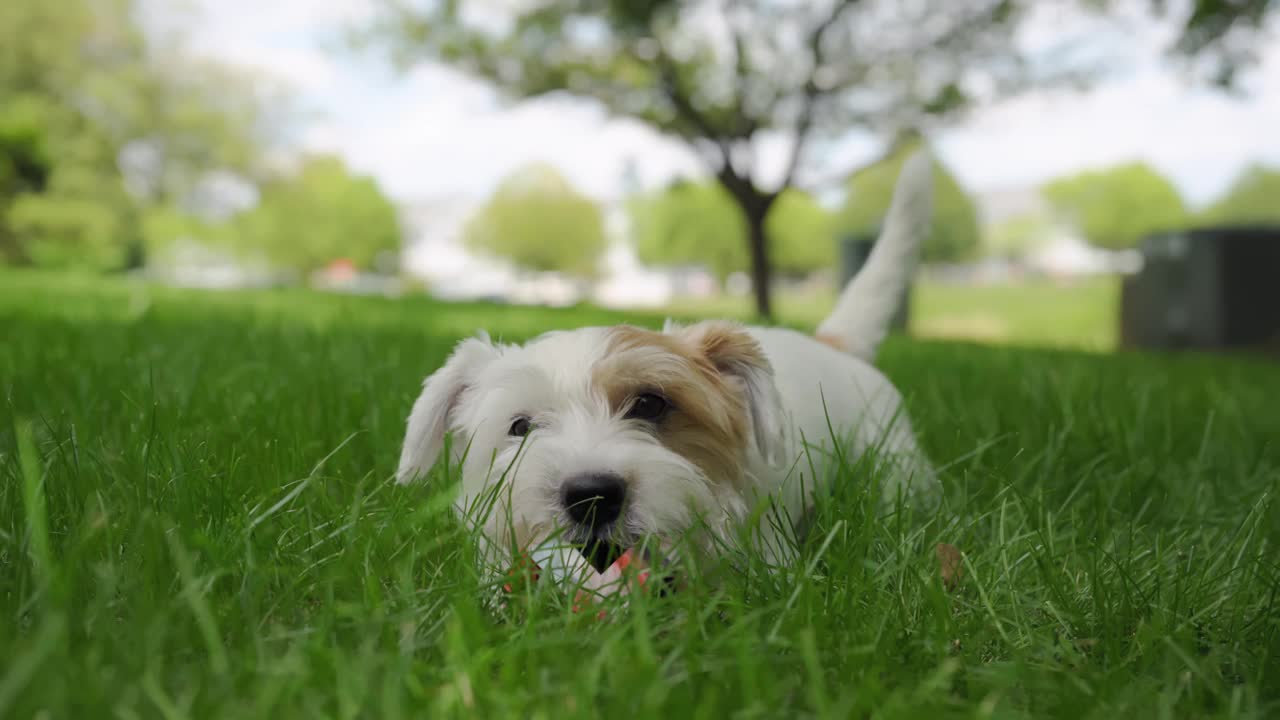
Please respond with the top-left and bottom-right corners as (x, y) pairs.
(667, 320), (786, 462)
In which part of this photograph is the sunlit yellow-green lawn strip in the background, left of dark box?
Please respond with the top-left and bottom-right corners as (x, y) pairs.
(671, 278), (1120, 351)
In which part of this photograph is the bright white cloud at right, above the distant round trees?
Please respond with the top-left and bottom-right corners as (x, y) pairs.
(940, 44), (1280, 204)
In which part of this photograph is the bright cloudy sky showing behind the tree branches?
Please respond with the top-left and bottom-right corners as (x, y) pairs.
(175, 0), (1280, 205)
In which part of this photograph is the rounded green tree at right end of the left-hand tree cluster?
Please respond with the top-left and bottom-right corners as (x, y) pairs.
(230, 155), (401, 272)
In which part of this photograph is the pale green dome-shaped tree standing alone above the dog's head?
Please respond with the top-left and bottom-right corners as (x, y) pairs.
(463, 165), (608, 278)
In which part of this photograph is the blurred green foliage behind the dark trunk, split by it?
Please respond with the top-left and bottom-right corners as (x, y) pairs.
(628, 182), (836, 282)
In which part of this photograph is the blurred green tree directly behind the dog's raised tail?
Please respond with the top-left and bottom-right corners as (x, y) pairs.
(838, 135), (979, 263)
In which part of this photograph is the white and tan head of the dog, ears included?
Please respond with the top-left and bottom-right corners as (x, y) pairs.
(397, 323), (782, 565)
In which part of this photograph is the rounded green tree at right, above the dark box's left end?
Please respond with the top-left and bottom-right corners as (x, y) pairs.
(1044, 163), (1188, 250)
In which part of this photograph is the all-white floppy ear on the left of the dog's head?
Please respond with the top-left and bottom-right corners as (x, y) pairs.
(396, 337), (498, 484)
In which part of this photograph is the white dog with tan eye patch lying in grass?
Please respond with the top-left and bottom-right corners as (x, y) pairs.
(397, 154), (937, 570)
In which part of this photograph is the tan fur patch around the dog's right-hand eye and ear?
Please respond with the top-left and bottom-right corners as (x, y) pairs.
(591, 323), (767, 484)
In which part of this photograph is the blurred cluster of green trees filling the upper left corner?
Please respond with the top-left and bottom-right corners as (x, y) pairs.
(0, 0), (399, 270)
